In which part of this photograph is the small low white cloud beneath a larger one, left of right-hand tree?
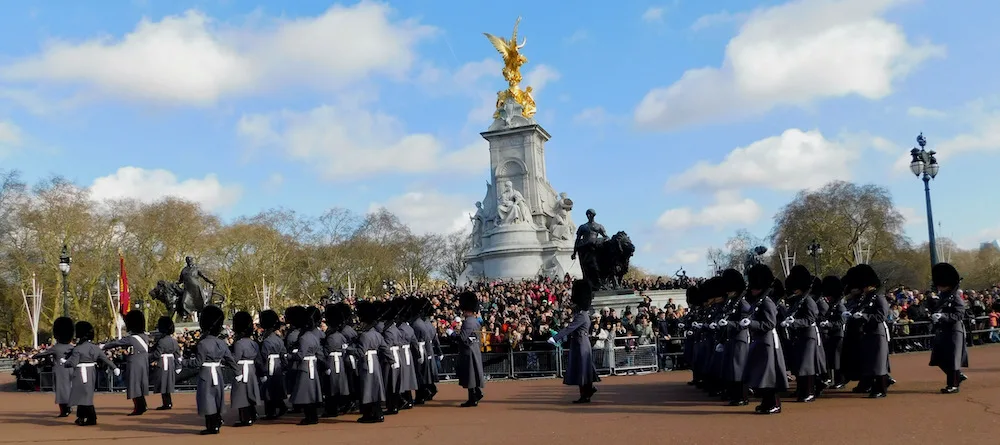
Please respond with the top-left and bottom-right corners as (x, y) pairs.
(656, 192), (763, 231)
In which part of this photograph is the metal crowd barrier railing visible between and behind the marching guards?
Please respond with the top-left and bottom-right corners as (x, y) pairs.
(27, 317), (1000, 392)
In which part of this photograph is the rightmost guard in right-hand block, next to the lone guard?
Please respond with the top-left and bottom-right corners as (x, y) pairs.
(847, 264), (889, 399)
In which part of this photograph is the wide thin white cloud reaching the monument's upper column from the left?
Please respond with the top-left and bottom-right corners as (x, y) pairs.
(237, 101), (489, 181)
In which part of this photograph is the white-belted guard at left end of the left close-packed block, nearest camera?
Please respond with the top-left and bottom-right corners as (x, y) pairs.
(191, 305), (237, 435)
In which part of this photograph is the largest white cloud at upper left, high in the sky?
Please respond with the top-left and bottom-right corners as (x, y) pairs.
(0, 0), (435, 105)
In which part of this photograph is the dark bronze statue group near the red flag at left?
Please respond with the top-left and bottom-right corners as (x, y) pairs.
(149, 257), (226, 319)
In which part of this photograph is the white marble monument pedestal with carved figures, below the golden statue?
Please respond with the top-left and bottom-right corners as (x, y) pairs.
(460, 97), (581, 283)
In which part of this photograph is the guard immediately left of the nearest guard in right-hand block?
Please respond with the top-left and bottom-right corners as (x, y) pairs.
(718, 269), (751, 406)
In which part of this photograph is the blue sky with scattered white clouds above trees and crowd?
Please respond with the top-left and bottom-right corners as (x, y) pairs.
(0, 0), (1000, 275)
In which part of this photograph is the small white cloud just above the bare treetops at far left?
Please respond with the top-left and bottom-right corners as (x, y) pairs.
(90, 167), (243, 211)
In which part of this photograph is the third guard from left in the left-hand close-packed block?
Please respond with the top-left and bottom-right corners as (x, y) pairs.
(257, 309), (288, 420)
